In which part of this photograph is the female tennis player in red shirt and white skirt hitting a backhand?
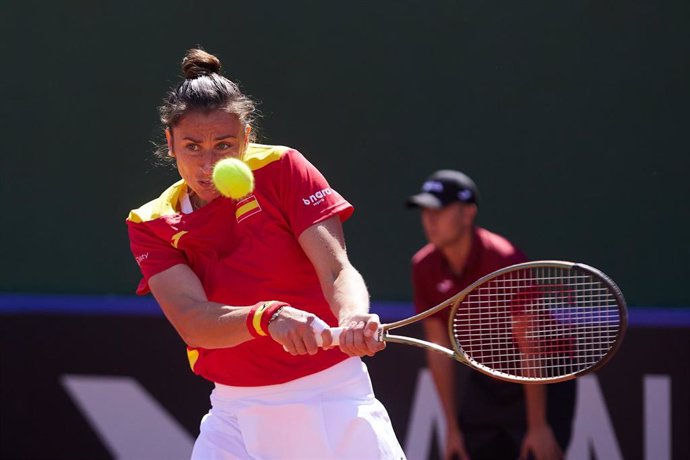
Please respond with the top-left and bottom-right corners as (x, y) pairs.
(127, 49), (404, 460)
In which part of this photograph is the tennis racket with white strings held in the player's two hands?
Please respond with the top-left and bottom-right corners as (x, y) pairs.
(312, 260), (627, 383)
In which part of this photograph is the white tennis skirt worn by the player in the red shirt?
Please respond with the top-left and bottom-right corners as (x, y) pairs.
(192, 358), (405, 460)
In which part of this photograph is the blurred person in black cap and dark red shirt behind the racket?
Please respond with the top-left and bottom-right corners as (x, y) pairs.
(407, 170), (575, 460)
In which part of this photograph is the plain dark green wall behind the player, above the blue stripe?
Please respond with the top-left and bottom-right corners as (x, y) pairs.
(0, 0), (690, 306)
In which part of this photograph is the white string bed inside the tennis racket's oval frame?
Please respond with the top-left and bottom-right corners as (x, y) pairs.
(452, 267), (621, 379)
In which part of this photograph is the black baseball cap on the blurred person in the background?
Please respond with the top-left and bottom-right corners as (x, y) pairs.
(407, 169), (479, 209)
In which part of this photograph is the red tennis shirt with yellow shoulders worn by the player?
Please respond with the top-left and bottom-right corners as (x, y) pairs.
(127, 144), (353, 386)
